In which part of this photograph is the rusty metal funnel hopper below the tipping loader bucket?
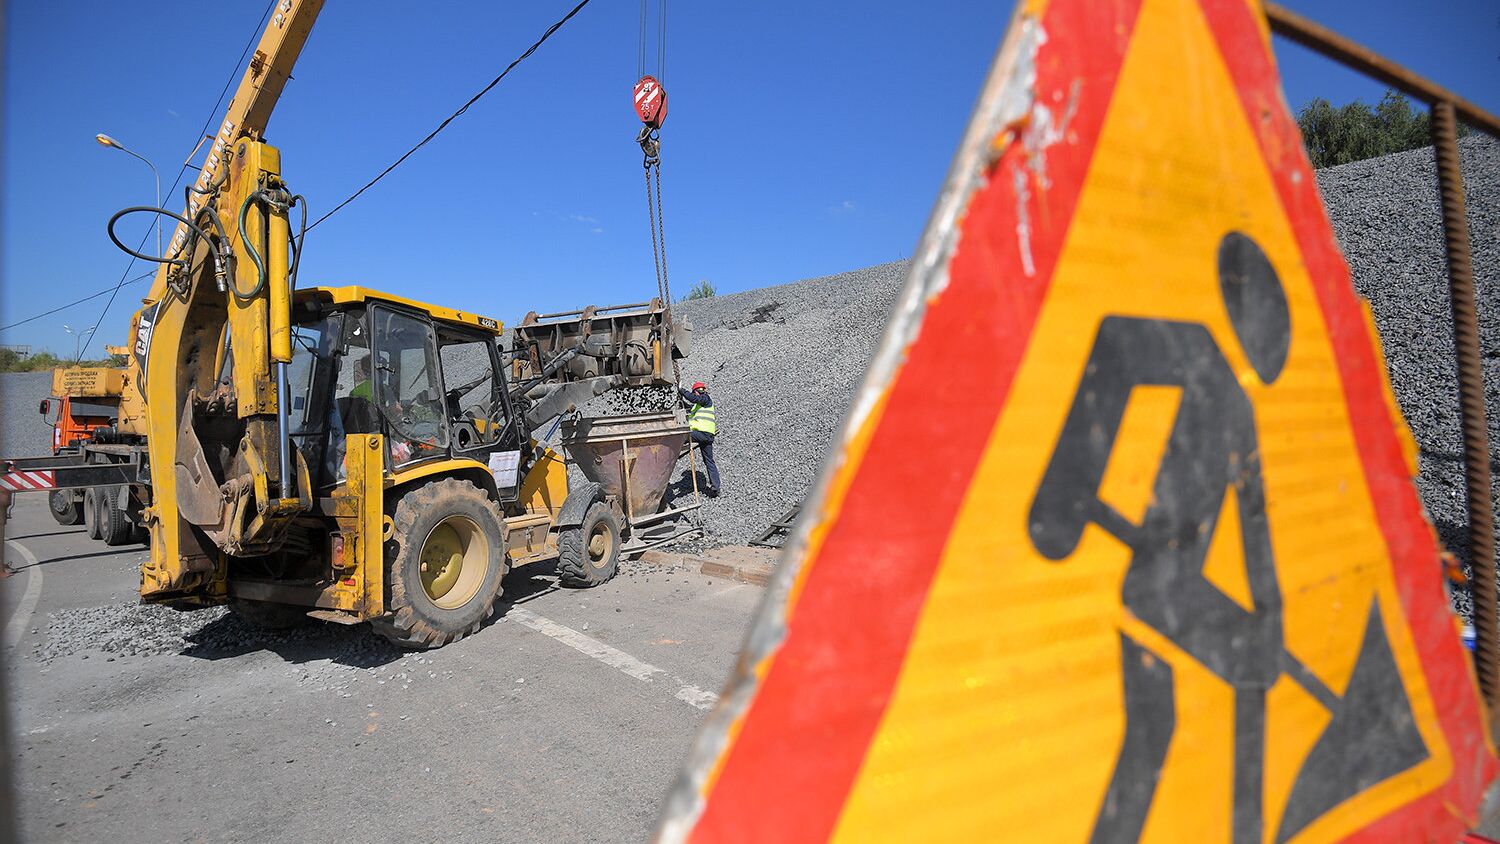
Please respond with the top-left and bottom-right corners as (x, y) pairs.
(563, 412), (689, 525)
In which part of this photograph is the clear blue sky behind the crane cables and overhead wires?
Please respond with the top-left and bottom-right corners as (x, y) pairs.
(0, 0), (1500, 354)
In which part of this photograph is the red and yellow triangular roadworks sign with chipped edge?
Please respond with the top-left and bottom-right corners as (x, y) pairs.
(663, 0), (1496, 843)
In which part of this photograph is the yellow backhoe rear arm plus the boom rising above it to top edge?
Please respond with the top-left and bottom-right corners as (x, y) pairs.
(123, 0), (323, 604)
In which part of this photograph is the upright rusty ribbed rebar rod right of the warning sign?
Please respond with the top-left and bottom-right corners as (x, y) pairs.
(1433, 102), (1500, 708)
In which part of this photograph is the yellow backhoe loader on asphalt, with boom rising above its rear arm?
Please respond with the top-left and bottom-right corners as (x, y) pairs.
(111, 0), (686, 648)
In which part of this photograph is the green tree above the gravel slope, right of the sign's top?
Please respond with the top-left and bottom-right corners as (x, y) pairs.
(1298, 90), (1469, 168)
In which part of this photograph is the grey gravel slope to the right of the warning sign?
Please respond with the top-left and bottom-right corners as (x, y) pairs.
(1317, 136), (1500, 615)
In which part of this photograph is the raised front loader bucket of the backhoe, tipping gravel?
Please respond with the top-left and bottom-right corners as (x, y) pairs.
(512, 298), (693, 387)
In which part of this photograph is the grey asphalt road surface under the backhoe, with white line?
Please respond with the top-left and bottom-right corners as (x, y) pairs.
(0, 496), (762, 843)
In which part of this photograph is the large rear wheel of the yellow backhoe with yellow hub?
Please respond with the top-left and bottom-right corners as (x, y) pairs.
(371, 478), (507, 648)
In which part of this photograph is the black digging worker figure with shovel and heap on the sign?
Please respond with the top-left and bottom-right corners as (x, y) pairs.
(1029, 231), (1428, 844)
